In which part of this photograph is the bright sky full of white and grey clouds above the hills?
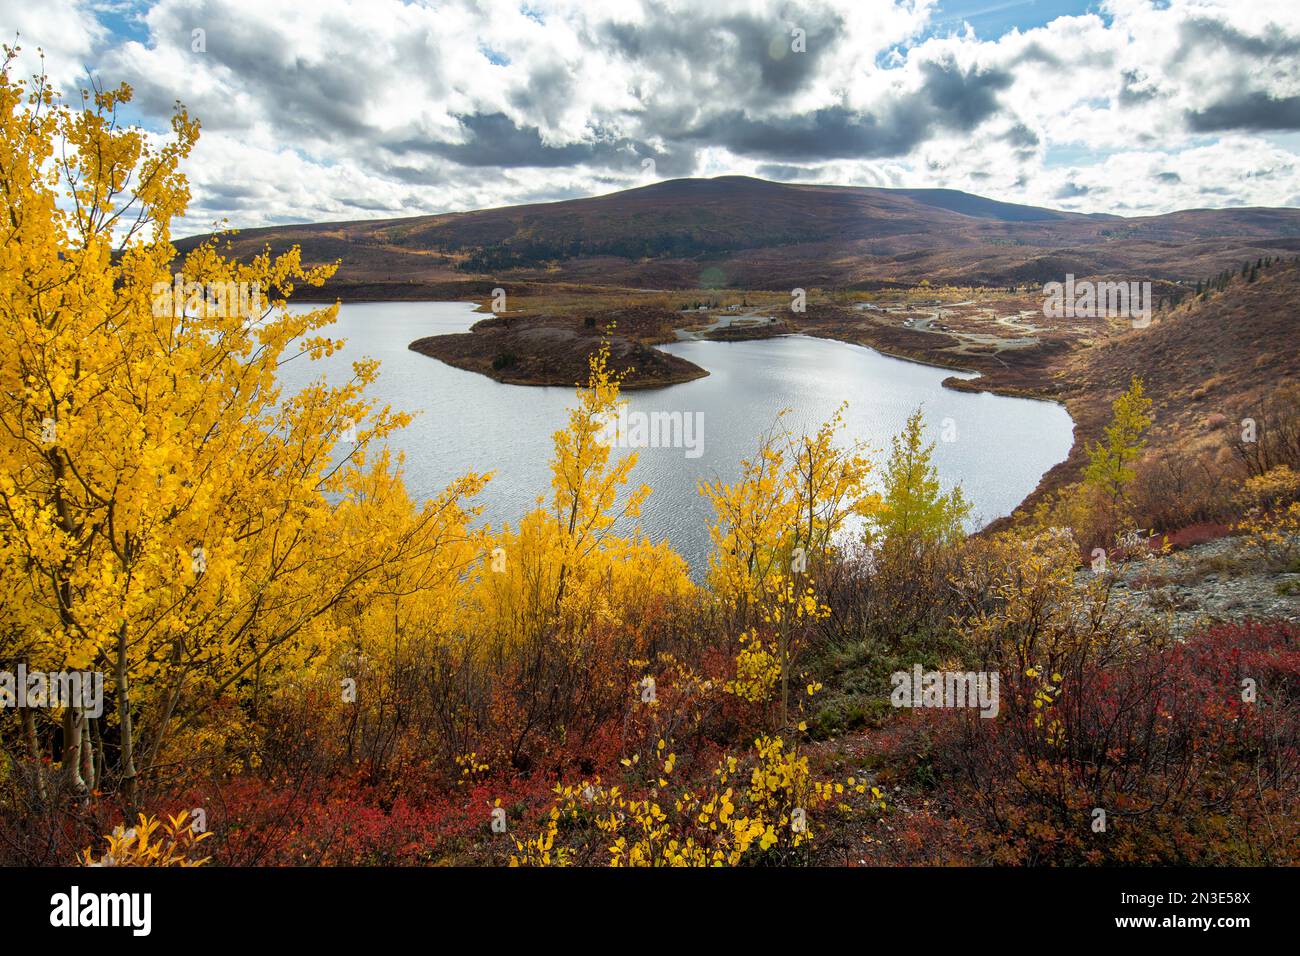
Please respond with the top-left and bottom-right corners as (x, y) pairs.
(10, 0), (1300, 234)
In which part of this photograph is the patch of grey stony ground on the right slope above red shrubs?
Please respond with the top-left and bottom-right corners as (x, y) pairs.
(1080, 537), (1300, 635)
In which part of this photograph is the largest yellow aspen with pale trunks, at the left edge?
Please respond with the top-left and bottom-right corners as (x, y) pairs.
(0, 62), (477, 806)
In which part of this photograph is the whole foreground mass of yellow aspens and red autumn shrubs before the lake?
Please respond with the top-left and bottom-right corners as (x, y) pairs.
(0, 59), (1300, 866)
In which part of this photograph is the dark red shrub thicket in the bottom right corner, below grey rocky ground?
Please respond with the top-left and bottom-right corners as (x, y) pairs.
(884, 623), (1300, 865)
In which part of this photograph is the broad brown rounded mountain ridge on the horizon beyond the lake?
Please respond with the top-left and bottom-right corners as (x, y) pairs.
(176, 176), (1300, 298)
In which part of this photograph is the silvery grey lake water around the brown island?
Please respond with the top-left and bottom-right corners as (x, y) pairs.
(281, 302), (1074, 574)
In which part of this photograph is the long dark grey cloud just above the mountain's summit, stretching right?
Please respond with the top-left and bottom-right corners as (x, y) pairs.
(679, 60), (1011, 160)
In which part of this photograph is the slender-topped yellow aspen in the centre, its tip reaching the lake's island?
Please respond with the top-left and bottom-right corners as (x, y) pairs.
(469, 345), (694, 760)
